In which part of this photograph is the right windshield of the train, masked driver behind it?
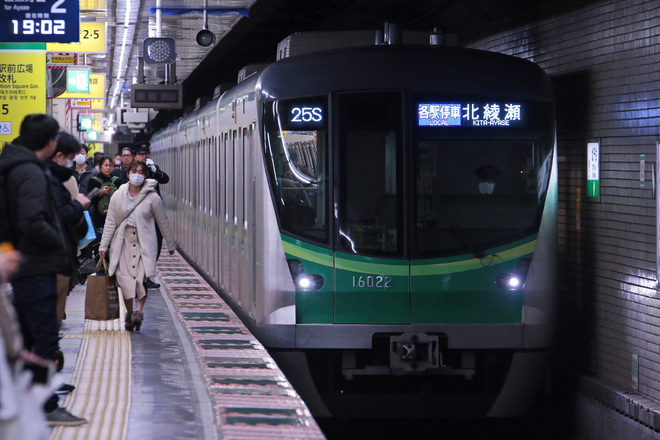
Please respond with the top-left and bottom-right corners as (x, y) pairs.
(414, 138), (552, 258)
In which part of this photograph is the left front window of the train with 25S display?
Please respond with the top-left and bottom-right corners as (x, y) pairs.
(264, 97), (328, 244)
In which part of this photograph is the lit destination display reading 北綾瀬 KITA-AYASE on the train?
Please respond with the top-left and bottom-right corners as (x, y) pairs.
(417, 102), (525, 127)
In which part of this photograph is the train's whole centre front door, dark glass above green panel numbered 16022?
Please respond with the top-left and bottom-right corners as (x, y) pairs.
(334, 92), (410, 323)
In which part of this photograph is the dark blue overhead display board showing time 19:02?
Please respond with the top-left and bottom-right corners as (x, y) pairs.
(0, 0), (80, 43)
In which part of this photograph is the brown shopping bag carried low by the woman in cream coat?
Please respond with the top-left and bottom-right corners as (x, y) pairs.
(85, 258), (119, 321)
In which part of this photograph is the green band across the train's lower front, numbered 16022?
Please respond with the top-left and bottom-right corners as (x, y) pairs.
(282, 235), (537, 324)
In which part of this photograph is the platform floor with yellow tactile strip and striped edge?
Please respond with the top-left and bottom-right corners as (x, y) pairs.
(50, 253), (325, 440)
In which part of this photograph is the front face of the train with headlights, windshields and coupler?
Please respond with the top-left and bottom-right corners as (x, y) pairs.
(257, 46), (557, 417)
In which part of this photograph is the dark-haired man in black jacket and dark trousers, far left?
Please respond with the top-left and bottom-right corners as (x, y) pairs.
(0, 114), (87, 426)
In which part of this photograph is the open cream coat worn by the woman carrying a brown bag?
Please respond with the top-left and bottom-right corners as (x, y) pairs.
(99, 179), (176, 278)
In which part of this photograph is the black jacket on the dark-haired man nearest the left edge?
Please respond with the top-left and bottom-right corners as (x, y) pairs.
(0, 144), (70, 279)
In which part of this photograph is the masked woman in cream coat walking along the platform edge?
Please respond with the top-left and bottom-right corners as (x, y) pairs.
(99, 162), (176, 331)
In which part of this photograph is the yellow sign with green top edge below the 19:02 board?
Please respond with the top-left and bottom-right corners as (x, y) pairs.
(0, 43), (46, 148)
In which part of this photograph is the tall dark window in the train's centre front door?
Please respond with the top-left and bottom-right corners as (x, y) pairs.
(336, 92), (404, 257)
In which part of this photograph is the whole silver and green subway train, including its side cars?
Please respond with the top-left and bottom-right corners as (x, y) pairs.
(151, 34), (557, 418)
